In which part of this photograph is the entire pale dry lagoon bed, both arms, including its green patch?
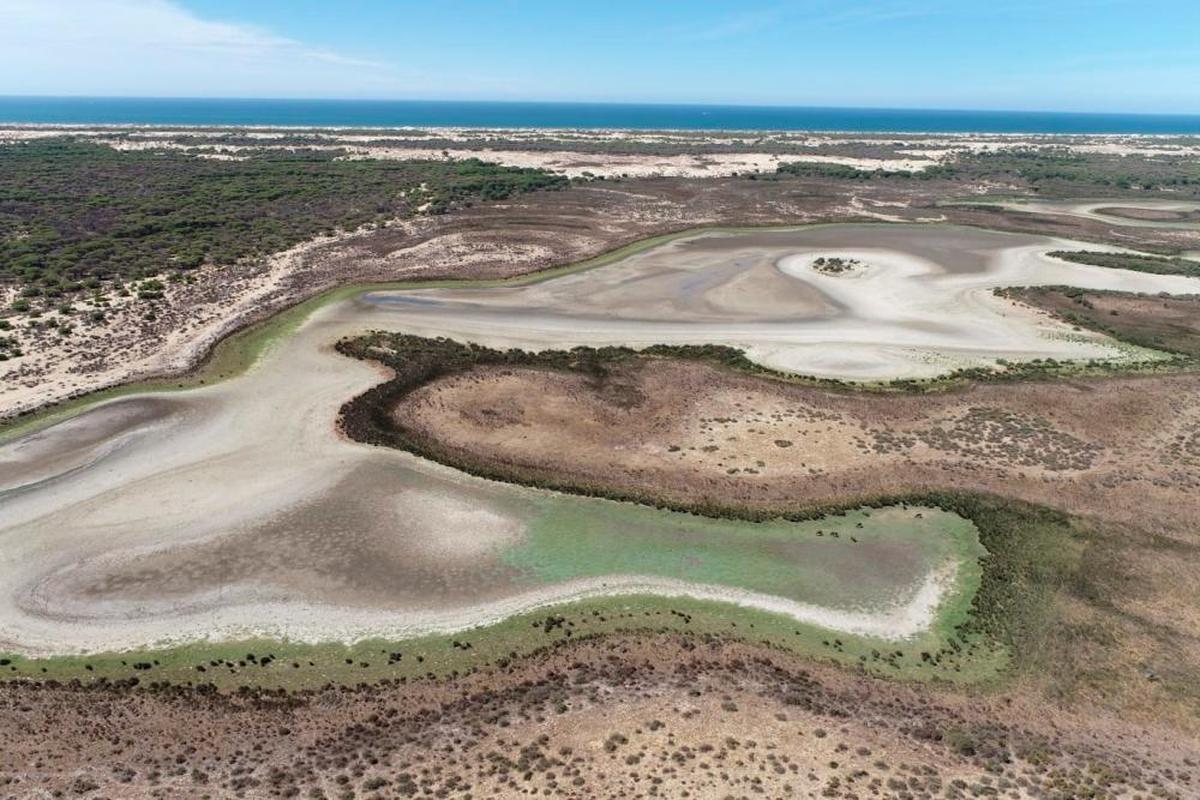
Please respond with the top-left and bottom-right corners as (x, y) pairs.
(0, 225), (1200, 654)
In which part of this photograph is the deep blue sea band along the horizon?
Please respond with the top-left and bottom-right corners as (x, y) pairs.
(0, 97), (1200, 134)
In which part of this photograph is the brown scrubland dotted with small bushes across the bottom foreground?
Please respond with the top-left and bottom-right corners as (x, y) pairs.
(0, 636), (1196, 798)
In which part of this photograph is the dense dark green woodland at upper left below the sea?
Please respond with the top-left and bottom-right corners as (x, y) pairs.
(0, 138), (569, 291)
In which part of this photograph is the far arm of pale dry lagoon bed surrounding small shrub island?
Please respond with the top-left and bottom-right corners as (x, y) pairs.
(352, 224), (1200, 380)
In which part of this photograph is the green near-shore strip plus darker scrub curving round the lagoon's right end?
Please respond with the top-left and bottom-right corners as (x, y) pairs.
(0, 493), (1099, 691)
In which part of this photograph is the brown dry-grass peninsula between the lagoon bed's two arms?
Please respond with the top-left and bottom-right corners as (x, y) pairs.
(394, 359), (1200, 534)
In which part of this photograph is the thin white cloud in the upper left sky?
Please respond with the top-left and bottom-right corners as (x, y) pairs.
(0, 0), (497, 97)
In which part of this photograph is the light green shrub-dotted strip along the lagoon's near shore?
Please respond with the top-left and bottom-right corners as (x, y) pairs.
(0, 595), (993, 691)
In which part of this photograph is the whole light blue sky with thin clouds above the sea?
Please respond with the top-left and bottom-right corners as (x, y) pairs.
(0, 0), (1200, 114)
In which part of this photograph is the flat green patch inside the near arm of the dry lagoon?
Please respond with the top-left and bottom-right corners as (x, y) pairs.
(511, 499), (983, 609)
